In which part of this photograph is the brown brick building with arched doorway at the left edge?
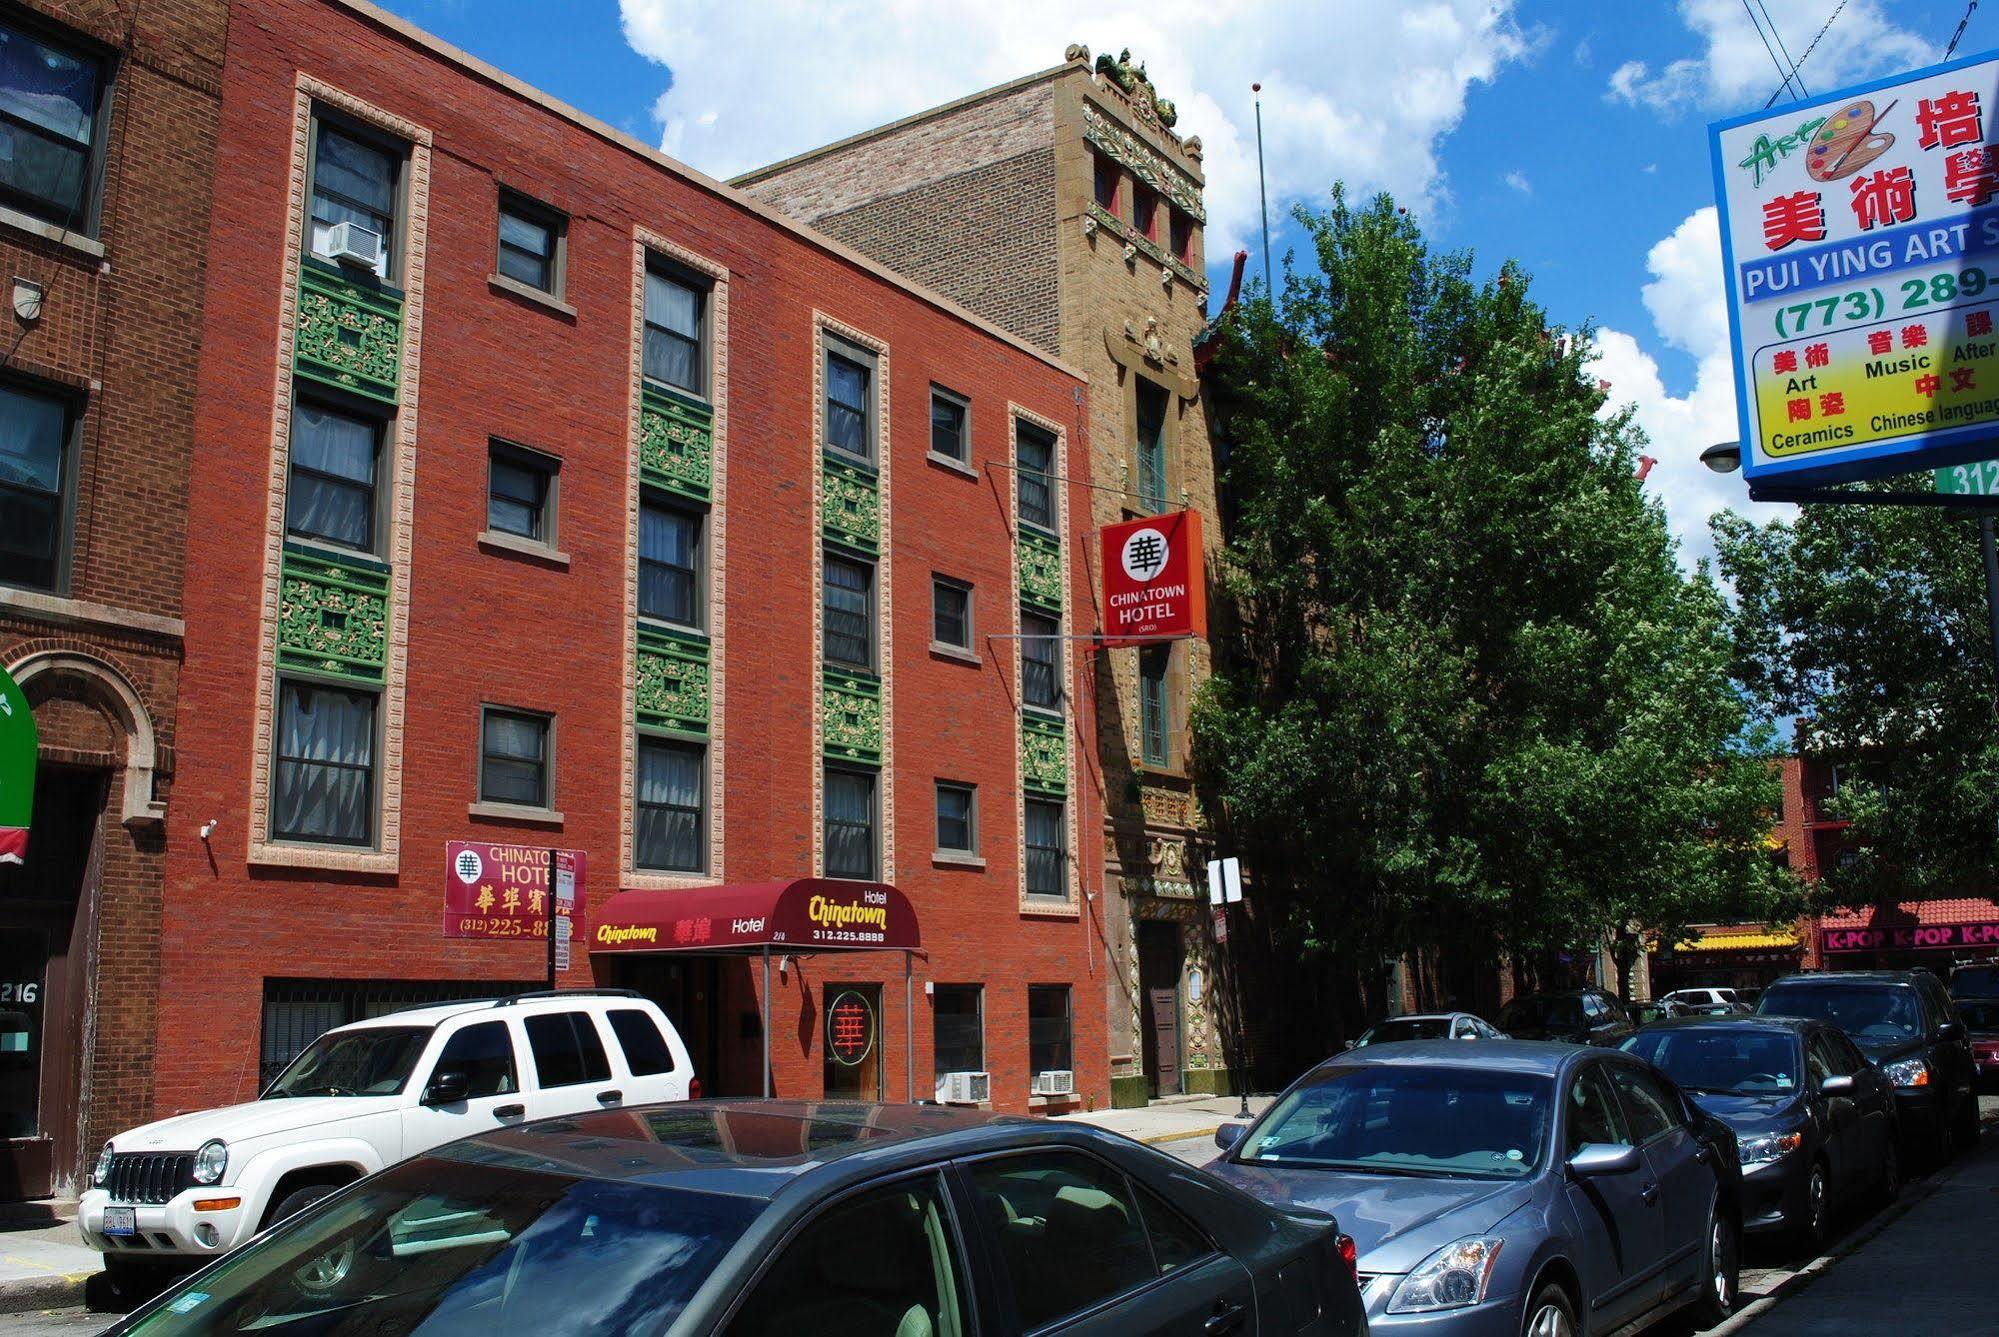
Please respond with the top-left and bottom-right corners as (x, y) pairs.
(0, 0), (228, 1201)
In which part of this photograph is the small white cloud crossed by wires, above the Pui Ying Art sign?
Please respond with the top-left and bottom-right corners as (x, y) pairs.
(1605, 0), (1937, 112)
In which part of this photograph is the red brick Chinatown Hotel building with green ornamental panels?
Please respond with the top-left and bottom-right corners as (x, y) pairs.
(156, 0), (1107, 1113)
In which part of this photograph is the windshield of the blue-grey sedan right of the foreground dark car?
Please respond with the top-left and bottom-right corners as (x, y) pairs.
(1235, 1063), (1549, 1179)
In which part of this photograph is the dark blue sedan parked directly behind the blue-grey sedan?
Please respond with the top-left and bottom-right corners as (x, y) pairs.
(1623, 1017), (1901, 1251)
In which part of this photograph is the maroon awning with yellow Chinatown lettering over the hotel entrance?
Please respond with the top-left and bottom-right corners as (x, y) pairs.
(590, 877), (924, 955)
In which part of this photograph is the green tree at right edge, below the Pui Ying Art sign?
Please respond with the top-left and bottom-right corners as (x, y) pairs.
(1713, 480), (1999, 905)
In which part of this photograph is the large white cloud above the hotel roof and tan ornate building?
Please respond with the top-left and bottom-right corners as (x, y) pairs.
(620, 0), (1547, 256)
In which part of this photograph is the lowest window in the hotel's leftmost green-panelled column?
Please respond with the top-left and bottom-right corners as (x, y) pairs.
(270, 681), (376, 845)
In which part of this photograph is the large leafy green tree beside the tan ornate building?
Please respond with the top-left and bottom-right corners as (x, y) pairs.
(1191, 192), (1781, 1045)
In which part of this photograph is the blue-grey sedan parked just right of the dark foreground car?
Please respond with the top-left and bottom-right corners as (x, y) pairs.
(1209, 1039), (1741, 1337)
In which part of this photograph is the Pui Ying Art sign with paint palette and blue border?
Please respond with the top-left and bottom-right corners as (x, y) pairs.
(1709, 54), (1999, 488)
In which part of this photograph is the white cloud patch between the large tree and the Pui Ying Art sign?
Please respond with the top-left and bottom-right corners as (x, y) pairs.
(1595, 206), (1781, 566)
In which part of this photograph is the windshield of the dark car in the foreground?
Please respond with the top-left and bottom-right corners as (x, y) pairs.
(130, 1159), (758, 1337)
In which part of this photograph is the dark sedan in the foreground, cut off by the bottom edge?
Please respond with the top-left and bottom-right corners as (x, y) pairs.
(112, 1101), (1365, 1337)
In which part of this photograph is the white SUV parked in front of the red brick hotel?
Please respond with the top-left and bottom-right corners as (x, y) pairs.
(76, 989), (700, 1285)
